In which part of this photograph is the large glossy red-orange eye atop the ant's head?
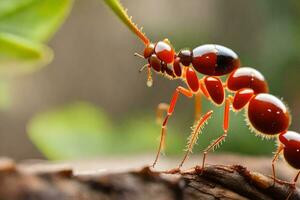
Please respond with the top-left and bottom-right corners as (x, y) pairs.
(154, 41), (175, 63)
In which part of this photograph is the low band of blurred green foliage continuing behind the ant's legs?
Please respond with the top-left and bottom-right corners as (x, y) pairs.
(27, 102), (274, 160)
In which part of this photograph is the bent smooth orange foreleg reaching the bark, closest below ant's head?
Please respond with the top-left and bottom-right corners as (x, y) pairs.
(152, 86), (193, 168)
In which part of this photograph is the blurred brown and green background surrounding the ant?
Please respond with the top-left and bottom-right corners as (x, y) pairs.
(0, 0), (300, 162)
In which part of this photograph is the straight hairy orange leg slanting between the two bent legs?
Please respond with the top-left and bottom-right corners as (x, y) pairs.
(178, 110), (213, 169)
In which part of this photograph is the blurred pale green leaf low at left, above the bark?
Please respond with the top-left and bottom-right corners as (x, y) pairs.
(27, 102), (112, 159)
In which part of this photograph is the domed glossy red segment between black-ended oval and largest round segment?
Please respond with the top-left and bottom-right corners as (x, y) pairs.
(227, 67), (269, 94)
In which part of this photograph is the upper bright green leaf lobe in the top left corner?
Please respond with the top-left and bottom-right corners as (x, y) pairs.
(0, 0), (72, 42)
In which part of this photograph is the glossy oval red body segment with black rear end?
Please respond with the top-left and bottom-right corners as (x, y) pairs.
(192, 44), (240, 76)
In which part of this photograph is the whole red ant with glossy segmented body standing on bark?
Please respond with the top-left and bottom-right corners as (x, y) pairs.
(105, 0), (300, 196)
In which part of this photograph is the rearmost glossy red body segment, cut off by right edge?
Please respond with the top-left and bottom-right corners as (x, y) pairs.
(279, 131), (300, 169)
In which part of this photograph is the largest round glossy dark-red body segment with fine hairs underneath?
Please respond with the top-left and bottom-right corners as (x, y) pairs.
(247, 93), (290, 136)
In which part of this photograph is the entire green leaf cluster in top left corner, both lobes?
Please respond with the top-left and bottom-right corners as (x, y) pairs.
(0, 0), (73, 76)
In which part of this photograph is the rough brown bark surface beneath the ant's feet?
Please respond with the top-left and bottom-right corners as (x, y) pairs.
(0, 160), (300, 200)
